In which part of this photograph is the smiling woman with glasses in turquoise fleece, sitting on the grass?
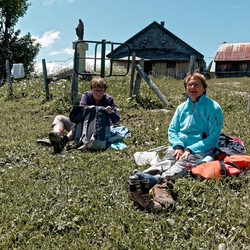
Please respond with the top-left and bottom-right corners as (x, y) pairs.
(129, 73), (223, 209)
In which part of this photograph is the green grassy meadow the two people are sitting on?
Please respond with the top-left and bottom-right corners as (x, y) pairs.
(0, 77), (250, 250)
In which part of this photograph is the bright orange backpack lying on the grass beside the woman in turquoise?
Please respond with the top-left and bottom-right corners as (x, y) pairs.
(190, 155), (250, 180)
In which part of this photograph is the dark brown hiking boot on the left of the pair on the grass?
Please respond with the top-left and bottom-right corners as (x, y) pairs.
(128, 180), (162, 211)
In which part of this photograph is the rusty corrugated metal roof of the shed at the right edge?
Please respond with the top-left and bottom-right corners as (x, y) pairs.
(214, 42), (250, 62)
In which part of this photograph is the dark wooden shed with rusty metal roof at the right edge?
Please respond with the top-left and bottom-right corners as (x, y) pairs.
(214, 42), (250, 77)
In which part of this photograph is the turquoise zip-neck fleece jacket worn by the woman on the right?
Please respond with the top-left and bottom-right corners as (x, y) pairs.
(168, 94), (223, 154)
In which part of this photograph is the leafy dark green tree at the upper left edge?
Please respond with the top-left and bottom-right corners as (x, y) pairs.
(0, 0), (41, 82)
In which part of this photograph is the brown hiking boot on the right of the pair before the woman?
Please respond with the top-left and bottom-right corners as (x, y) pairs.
(150, 181), (175, 205)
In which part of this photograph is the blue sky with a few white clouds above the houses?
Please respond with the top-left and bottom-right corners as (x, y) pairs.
(15, 0), (250, 73)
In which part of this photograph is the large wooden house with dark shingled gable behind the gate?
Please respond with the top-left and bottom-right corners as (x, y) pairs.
(107, 21), (204, 78)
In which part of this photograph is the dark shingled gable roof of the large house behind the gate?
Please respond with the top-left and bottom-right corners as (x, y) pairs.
(107, 21), (204, 61)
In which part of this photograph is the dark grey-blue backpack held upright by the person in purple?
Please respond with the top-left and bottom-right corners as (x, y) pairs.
(69, 106), (107, 151)
